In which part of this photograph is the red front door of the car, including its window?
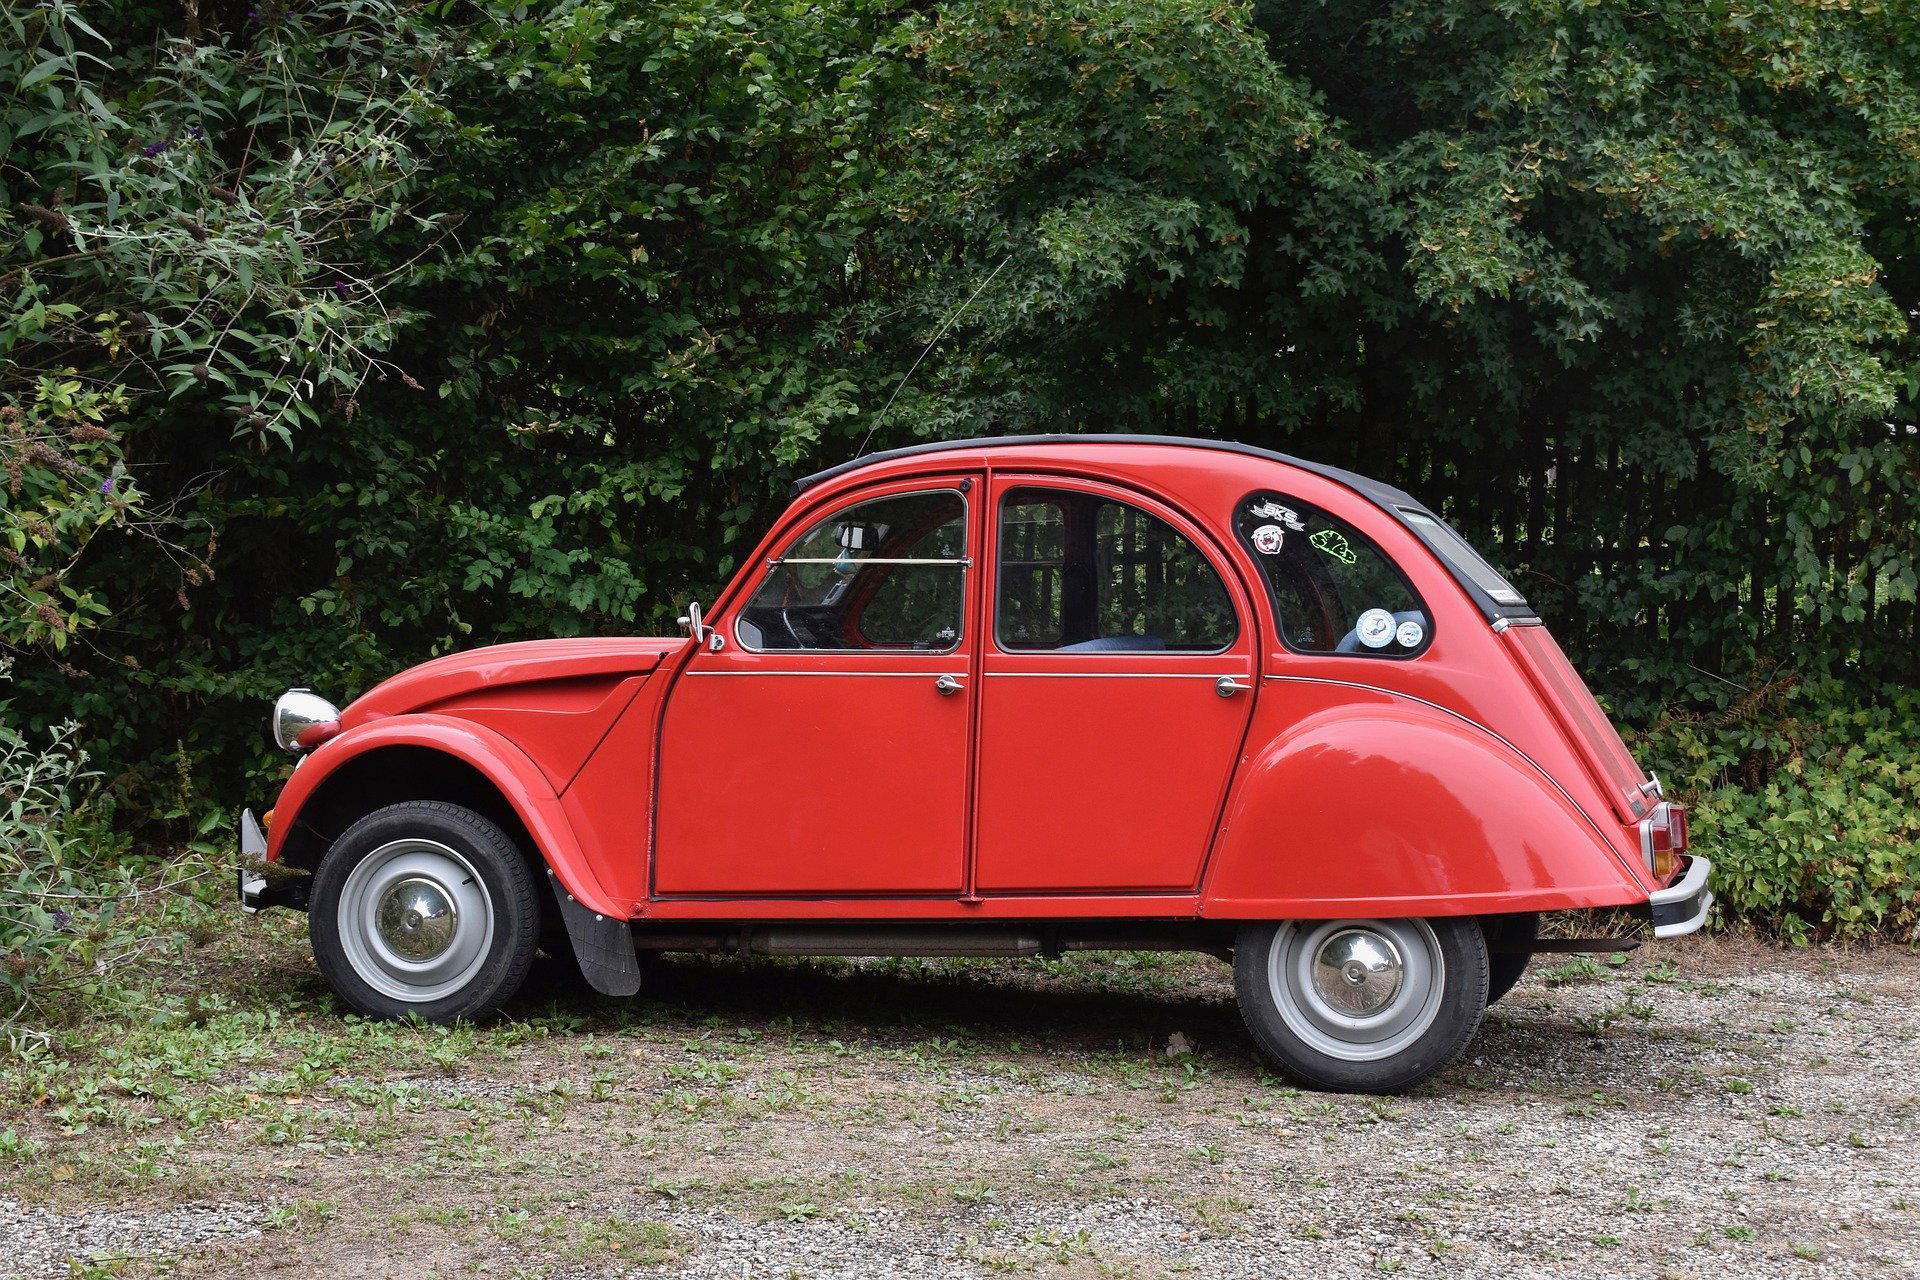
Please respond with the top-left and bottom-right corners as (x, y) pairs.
(653, 474), (983, 896)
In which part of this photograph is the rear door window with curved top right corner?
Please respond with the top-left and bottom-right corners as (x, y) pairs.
(995, 487), (1238, 652)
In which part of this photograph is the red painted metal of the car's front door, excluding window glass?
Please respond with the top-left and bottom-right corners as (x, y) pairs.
(653, 472), (979, 896)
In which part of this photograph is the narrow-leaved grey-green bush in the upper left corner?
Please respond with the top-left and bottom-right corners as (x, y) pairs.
(0, 0), (434, 651)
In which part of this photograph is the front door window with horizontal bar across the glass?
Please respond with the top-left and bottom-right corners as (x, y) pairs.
(735, 489), (966, 652)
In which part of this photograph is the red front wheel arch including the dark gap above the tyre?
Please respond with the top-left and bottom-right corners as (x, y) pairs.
(267, 716), (630, 919)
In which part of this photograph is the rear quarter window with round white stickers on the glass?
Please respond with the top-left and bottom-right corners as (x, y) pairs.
(1235, 493), (1432, 658)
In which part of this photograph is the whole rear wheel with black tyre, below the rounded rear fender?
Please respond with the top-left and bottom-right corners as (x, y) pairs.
(1233, 917), (1488, 1094)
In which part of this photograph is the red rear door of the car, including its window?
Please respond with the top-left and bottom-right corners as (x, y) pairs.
(973, 476), (1258, 894)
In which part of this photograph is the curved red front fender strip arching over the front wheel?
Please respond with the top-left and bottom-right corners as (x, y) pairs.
(267, 714), (632, 919)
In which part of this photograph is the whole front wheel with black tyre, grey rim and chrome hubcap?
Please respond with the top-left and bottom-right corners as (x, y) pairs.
(307, 800), (540, 1023)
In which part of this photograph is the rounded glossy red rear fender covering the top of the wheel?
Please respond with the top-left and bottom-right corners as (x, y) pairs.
(1200, 691), (1647, 919)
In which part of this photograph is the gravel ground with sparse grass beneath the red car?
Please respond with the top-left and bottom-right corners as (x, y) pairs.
(0, 940), (1920, 1280)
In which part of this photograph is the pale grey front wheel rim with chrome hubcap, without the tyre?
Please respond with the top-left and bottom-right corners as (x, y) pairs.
(338, 839), (493, 1004)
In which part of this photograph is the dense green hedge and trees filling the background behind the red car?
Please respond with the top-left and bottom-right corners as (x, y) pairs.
(0, 0), (1920, 933)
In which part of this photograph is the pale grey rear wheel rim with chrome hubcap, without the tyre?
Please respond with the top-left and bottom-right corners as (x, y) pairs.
(1267, 919), (1446, 1061)
